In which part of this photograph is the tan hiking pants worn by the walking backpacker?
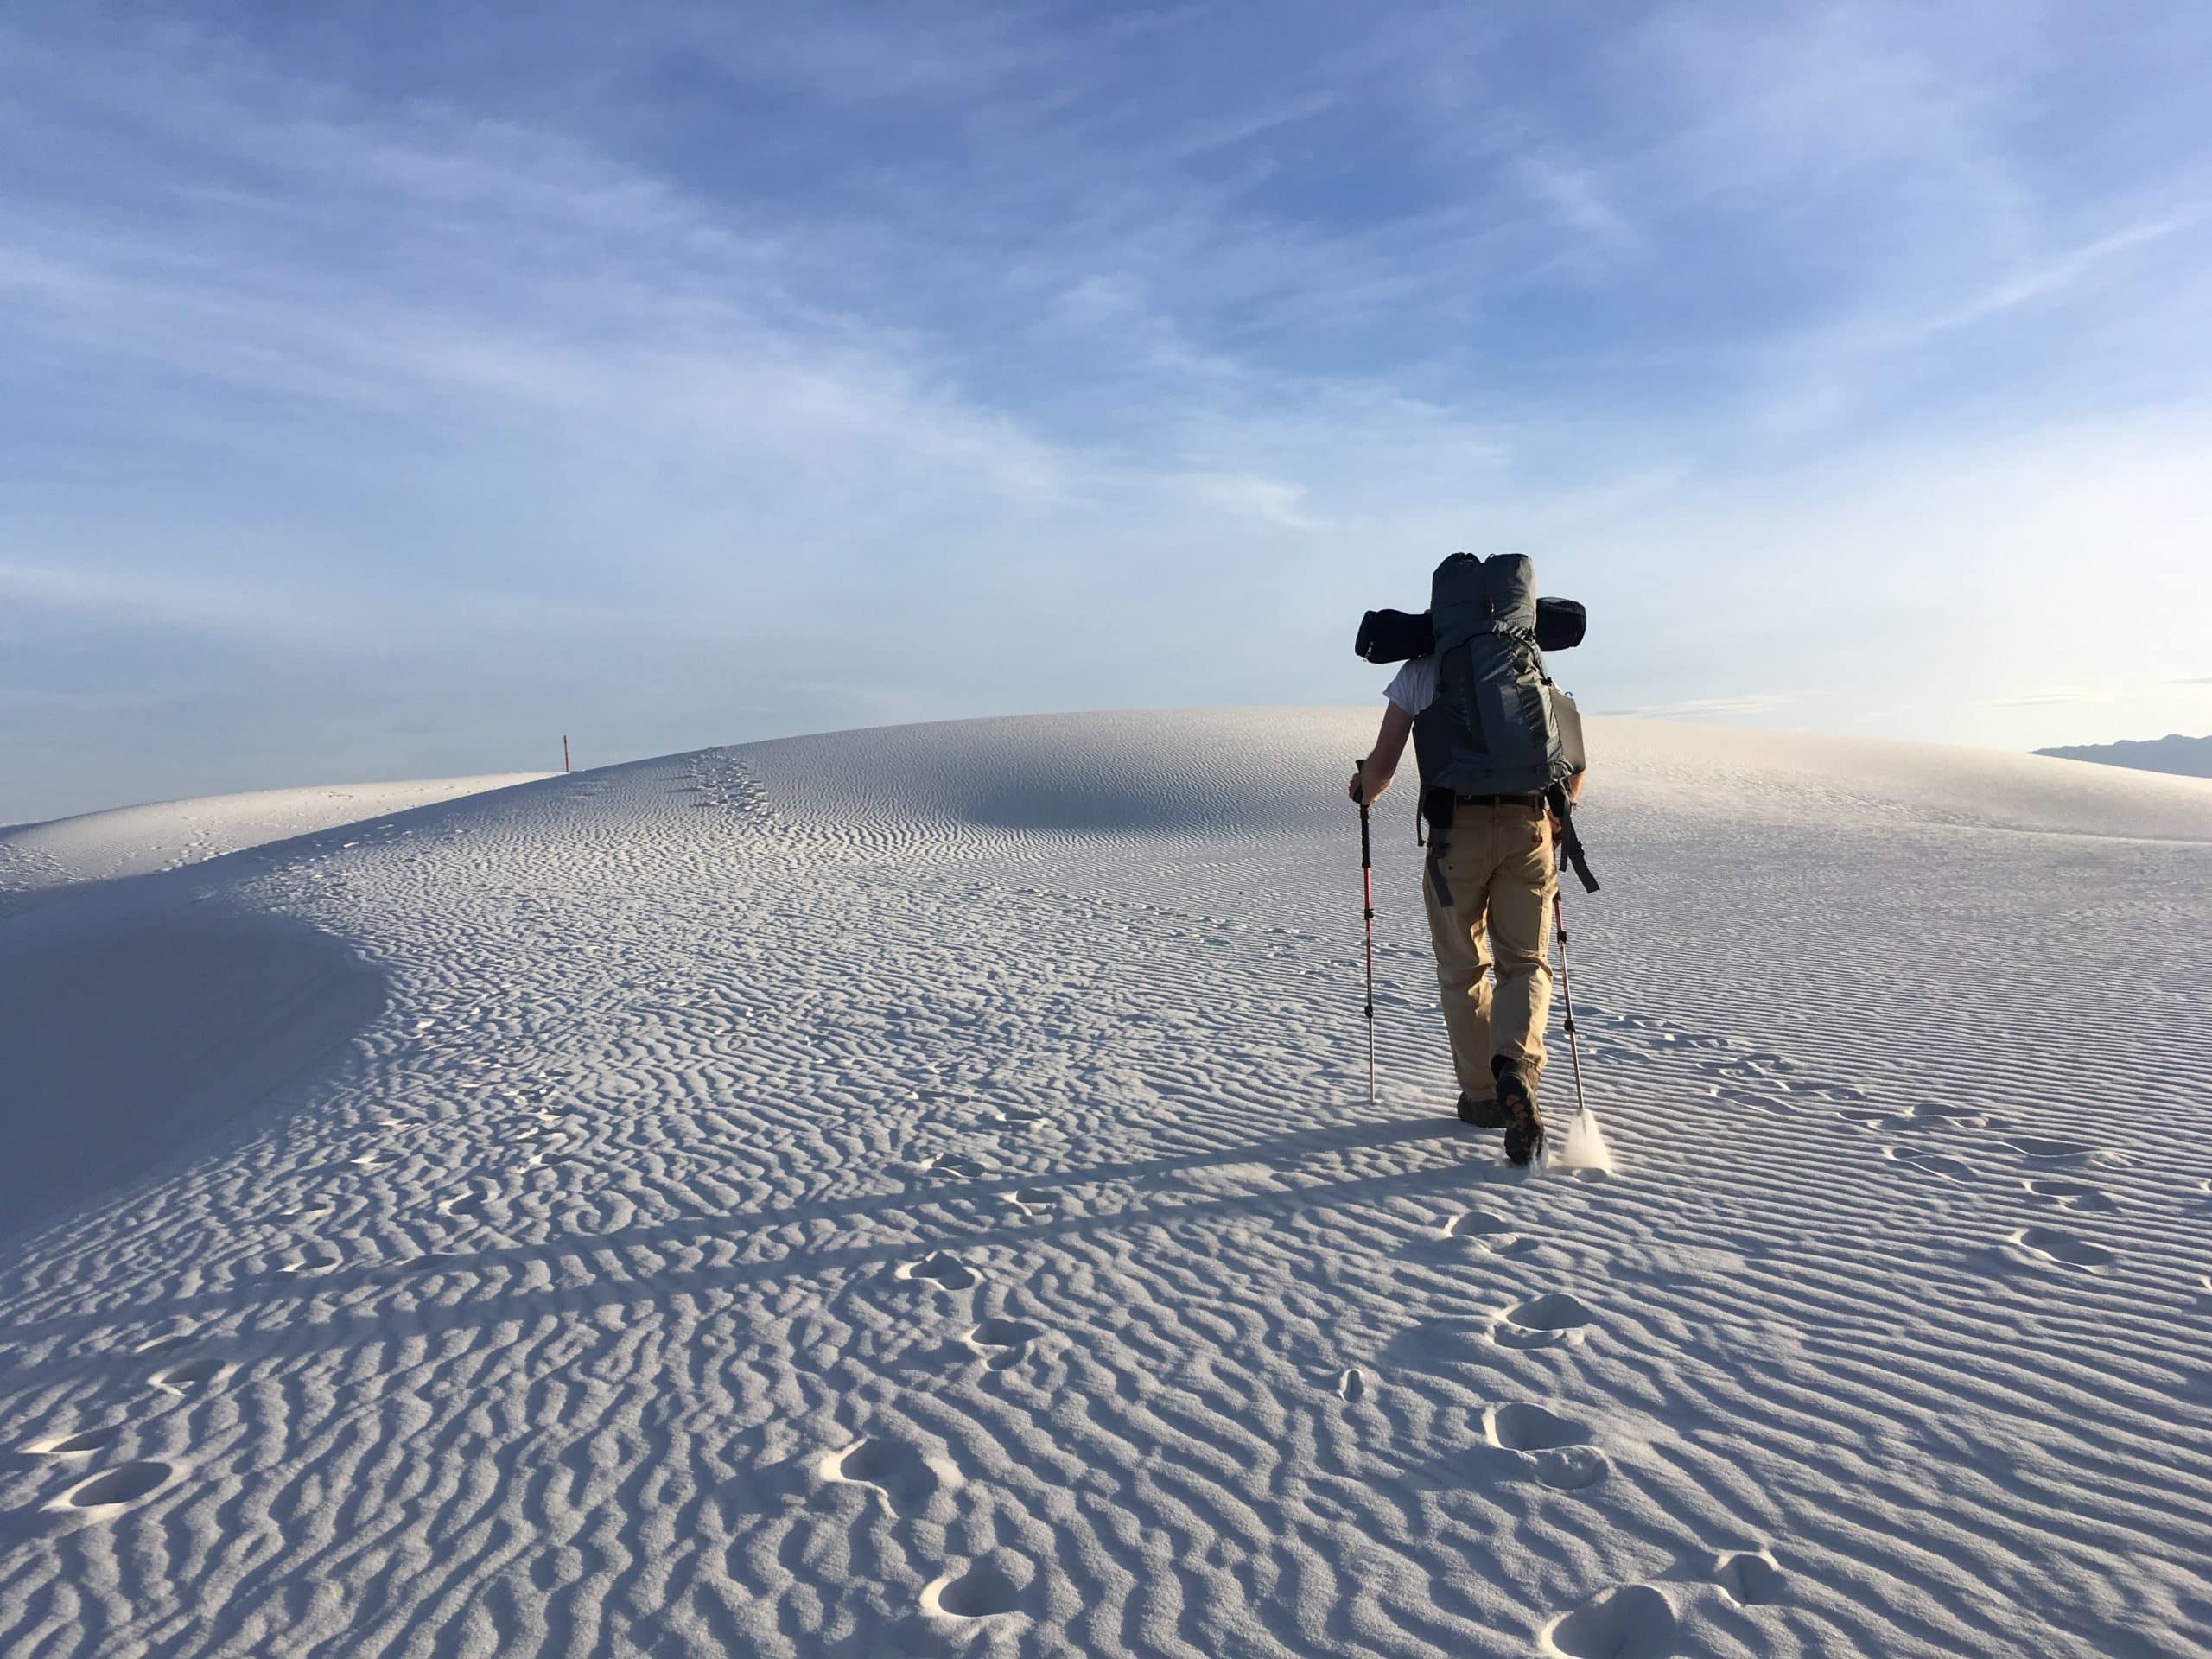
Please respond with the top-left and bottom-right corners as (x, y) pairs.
(1421, 801), (1560, 1099)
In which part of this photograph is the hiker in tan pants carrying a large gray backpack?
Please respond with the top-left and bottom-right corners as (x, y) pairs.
(1351, 553), (1586, 1164)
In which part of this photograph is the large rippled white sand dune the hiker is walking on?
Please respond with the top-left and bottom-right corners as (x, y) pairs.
(0, 710), (2212, 1659)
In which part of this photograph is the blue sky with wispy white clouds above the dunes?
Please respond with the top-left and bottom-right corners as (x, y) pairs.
(0, 0), (2212, 823)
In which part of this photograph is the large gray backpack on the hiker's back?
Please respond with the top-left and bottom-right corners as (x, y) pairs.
(1414, 553), (1581, 800)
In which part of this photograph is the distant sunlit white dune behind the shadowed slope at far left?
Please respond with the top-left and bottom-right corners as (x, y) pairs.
(0, 772), (546, 916)
